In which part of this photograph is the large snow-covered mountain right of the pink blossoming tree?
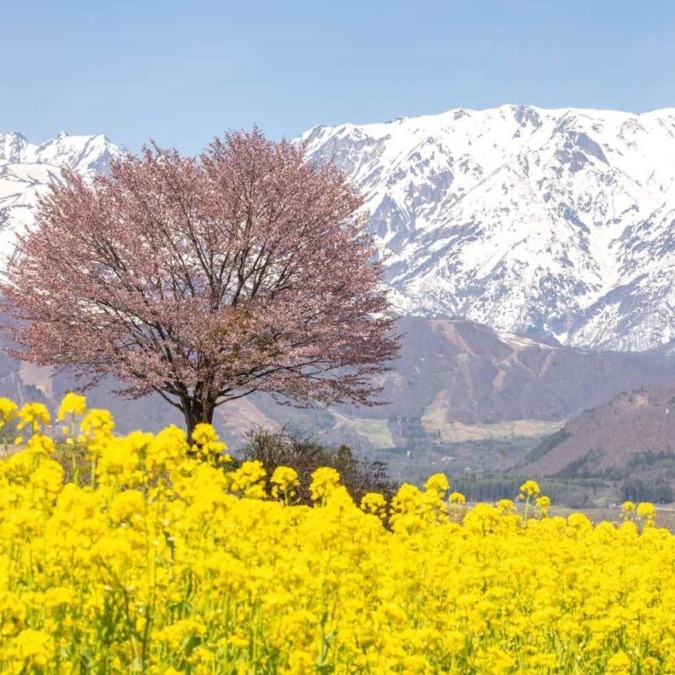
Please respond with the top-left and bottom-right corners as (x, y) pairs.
(302, 106), (675, 350)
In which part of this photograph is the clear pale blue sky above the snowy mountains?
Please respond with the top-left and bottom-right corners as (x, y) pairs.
(0, 0), (675, 153)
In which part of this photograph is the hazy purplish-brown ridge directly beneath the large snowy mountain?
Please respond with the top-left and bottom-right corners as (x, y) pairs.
(340, 318), (675, 424)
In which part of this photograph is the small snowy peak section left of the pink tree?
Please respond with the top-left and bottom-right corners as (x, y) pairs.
(0, 132), (120, 257)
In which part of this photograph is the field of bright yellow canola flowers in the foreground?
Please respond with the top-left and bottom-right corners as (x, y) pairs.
(0, 394), (675, 675)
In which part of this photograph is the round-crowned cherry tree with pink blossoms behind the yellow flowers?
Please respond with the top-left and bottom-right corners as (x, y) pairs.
(0, 129), (398, 430)
